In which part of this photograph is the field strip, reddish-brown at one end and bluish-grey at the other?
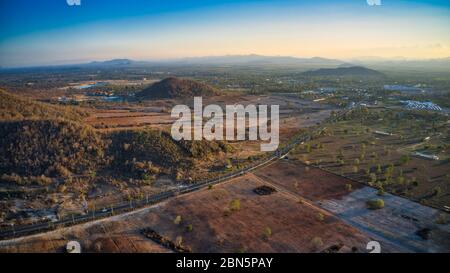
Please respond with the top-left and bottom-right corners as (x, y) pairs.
(256, 160), (450, 252)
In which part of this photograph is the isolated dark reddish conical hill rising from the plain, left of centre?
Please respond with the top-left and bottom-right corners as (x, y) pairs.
(136, 78), (218, 99)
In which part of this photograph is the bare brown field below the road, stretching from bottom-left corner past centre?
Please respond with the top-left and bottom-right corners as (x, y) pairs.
(0, 170), (382, 252)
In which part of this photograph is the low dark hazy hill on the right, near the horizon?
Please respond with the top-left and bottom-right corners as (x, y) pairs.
(303, 66), (384, 77)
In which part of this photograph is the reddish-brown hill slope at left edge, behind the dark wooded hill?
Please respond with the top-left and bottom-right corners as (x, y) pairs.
(0, 89), (86, 120)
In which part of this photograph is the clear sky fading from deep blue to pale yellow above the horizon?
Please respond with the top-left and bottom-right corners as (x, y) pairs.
(0, 0), (450, 67)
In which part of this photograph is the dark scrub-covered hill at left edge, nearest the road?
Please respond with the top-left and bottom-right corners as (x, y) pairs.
(0, 120), (105, 176)
